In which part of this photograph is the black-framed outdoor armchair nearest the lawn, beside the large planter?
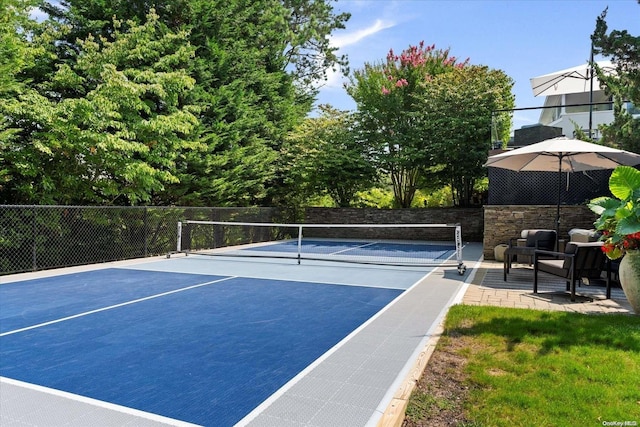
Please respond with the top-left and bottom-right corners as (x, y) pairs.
(533, 242), (611, 301)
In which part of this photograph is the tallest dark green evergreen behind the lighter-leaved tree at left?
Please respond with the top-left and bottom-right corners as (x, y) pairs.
(40, 0), (349, 205)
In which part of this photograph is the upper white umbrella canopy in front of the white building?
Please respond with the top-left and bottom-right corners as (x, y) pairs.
(530, 61), (615, 96)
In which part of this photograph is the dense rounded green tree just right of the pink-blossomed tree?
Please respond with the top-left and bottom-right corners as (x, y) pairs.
(419, 65), (515, 206)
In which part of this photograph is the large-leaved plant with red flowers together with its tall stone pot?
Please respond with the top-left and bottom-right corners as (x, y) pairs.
(588, 166), (640, 314)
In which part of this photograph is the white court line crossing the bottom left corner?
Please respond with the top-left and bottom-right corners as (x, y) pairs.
(0, 376), (198, 427)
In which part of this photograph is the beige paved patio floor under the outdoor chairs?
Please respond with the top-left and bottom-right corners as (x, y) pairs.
(462, 261), (633, 314)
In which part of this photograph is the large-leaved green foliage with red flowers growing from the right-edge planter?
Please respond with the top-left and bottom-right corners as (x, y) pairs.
(587, 166), (640, 259)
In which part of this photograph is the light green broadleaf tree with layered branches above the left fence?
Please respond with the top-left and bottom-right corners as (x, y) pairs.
(0, 13), (198, 204)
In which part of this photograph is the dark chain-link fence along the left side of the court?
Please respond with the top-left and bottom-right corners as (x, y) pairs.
(0, 205), (287, 275)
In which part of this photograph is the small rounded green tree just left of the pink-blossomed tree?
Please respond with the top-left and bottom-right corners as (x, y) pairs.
(286, 105), (377, 207)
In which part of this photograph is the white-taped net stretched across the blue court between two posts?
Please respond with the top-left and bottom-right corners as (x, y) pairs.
(176, 220), (466, 274)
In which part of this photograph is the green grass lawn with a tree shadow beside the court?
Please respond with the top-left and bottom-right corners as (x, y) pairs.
(404, 305), (640, 426)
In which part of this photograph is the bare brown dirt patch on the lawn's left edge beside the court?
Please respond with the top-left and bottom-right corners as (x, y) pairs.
(402, 336), (476, 427)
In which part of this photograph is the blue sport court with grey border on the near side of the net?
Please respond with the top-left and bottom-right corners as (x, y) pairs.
(0, 242), (479, 426)
